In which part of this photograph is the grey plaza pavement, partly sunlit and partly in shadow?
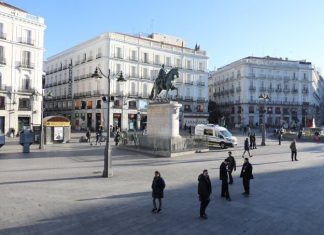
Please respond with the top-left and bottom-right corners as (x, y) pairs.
(0, 134), (324, 235)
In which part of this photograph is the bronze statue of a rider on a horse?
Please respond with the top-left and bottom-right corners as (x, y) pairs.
(149, 68), (179, 100)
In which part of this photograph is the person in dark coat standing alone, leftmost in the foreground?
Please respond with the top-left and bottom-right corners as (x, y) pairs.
(151, 171), (165, 213)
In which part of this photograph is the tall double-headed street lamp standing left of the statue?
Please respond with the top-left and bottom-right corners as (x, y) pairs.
(92, 67), (126, 178)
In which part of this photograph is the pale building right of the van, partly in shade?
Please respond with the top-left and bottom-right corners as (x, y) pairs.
(209, 56), (321, 127)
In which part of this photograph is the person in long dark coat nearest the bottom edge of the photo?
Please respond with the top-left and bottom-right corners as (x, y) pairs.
(198, 170), (212, 219)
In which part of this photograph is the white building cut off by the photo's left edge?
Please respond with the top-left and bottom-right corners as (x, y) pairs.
(0, 2), (46, 134)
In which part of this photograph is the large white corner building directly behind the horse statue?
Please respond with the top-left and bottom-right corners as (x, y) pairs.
(45, 33), (208, 130)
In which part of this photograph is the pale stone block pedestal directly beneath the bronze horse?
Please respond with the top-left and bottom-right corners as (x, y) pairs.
(147, 101), (182, 138)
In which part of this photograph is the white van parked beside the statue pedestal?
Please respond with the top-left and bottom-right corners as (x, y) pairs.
(195, 124), (237, 148)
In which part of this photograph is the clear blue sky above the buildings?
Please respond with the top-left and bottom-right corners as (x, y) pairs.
(6, 0), (324, 72)
